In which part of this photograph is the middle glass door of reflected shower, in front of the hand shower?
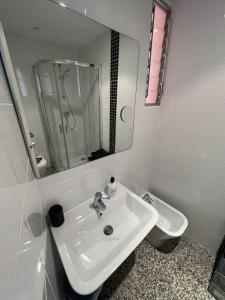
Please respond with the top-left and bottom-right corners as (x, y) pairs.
(57, 64), (87, 168)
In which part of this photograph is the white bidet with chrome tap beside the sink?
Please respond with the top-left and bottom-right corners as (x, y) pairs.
(141, 192), (188, 253)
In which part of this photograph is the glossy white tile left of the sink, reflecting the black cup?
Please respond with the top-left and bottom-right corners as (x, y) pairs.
(13, 160), (47, 300)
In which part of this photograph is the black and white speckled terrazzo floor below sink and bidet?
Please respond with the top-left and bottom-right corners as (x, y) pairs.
(99, 237), (215, 300)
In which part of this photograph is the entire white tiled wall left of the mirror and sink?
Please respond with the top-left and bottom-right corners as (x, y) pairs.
(0, 58), (57, 300)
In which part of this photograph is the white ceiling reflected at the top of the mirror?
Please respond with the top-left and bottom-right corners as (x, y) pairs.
(0, 0), (108, 49)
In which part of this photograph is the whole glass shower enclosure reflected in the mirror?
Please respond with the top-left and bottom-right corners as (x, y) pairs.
(33, 60), (100, 171)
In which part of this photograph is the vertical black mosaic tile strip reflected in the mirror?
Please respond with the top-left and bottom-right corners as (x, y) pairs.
(109, 30), (120, 153)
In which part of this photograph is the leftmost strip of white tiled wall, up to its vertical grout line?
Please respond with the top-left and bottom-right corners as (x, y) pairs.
(0, 58), (27, 299)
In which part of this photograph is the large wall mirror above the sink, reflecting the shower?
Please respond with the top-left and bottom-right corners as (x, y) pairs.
(0, 0), (139, 177)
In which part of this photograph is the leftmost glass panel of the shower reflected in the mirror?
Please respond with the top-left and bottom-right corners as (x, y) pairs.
(33, 62), (69, 170)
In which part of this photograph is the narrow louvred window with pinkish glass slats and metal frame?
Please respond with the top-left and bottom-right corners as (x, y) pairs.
(145, 1), (170, 105)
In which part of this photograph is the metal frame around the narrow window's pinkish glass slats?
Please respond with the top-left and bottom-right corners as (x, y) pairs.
(145, 0), (171, 106)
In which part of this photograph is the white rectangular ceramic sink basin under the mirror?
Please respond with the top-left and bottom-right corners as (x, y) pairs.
(51, 184), (158, 295)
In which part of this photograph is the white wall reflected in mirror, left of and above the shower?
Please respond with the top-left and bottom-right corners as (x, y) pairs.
(6, 32), (77, 166)
